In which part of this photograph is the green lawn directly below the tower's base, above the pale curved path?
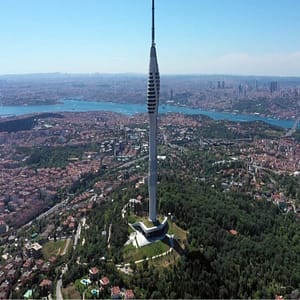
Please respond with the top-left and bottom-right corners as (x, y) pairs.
(124, 241), (169, 263)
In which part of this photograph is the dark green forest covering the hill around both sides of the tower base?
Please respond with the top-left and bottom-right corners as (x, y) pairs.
(64, 169), (300, 298)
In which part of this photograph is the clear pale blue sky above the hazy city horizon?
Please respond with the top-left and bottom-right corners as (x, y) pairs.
(0, 0), (300, 76)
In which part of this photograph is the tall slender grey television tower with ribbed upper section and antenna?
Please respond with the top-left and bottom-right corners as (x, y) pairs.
(147, 0), (160, 222)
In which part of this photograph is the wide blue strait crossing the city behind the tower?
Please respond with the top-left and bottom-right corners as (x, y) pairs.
(0, 100), (294, 128)
